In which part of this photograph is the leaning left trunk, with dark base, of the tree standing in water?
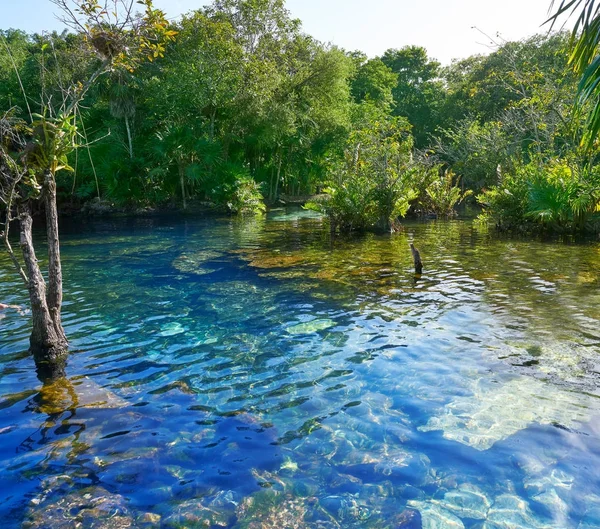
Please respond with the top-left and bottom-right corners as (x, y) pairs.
(19, 203), (67, 379)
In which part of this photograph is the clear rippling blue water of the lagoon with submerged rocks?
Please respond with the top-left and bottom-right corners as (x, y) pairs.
(0, 212), (600, 529)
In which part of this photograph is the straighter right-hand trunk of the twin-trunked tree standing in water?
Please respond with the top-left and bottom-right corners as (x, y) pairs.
(44, 171), (67, 344)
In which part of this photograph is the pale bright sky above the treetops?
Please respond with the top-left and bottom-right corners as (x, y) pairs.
(0, 0), (550, 64)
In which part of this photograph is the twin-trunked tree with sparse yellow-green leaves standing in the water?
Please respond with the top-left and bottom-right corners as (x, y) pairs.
(0, 0), (174, 376)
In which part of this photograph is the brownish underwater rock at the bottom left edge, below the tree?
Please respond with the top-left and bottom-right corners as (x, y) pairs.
(22, 486), (136, 529)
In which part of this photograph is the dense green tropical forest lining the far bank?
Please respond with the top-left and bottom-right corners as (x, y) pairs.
(0, 0), (600, 235)
